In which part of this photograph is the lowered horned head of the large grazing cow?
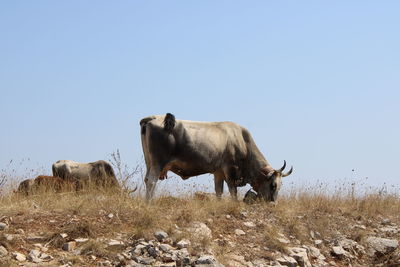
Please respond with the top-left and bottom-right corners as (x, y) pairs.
(253, 161), (293, 201)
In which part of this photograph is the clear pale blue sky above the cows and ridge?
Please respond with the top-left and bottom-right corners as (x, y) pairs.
(0, 1), (400, 192)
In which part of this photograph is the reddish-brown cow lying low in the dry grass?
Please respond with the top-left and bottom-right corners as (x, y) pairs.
(17, 175), (77, 195)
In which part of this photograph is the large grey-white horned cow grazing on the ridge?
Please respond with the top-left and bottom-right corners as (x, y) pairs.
(140, 113), (293, 201)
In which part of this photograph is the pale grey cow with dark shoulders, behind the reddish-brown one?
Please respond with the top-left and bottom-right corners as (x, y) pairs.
(52, 160), (120, 189)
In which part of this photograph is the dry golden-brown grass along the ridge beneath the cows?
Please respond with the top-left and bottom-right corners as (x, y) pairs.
(0, 177), (400, 262)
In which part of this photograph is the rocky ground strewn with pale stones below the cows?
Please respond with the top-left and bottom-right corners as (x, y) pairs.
(0, 193), (400, 267)
